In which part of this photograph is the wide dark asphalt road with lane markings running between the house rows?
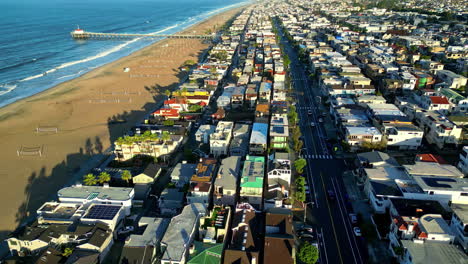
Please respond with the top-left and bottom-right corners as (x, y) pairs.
(279, 23), (367, 263)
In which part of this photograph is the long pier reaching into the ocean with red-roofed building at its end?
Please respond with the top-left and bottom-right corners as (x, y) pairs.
(70, 28), (215, 39)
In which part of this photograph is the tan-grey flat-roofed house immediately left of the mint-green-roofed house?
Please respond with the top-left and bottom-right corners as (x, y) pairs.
(213, 156), (241, 206)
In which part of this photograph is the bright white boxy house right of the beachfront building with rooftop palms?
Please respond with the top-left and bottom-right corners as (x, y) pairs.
(210, 121), (234, 157)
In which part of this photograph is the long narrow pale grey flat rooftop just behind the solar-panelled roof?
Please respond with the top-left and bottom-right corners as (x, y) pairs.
(57, 185), (134, 201)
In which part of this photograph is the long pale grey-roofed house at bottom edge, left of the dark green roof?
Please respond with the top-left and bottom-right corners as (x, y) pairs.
(161, 203), (206, 264)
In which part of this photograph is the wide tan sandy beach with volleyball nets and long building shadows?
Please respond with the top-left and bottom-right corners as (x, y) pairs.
(0, 8), (240, 238)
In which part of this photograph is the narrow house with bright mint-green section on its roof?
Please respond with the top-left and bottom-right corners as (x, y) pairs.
(240, 156), (265, 209)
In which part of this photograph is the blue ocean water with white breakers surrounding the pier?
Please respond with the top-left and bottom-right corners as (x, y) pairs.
(0, 0), (246, 107)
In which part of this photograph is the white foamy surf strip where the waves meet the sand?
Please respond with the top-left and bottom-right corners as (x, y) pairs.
(0, 2), (249, 109)
